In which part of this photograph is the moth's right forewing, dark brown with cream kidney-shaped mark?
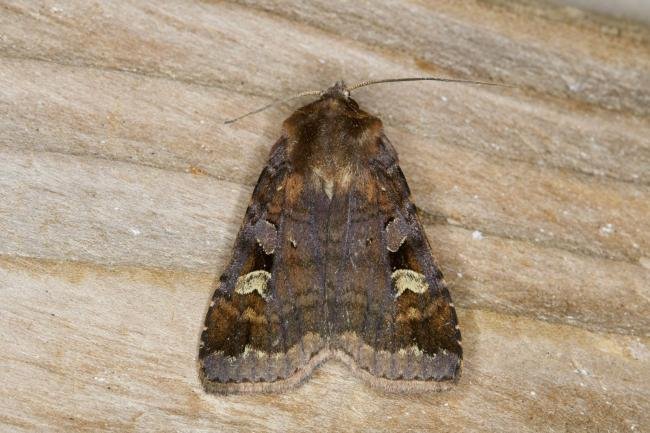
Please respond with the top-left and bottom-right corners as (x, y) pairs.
(338, 137), (462, 390)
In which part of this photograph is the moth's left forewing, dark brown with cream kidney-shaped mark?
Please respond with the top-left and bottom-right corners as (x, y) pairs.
(199, 140), (329, 393)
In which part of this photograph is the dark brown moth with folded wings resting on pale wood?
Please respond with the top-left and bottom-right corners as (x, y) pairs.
(199, 82), (463, 393)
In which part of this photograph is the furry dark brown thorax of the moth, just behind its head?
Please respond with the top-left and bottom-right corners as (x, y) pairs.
(284, 93), (382, 195)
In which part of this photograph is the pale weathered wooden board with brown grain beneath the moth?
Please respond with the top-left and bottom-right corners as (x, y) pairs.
(0, 0), (650, 432)
